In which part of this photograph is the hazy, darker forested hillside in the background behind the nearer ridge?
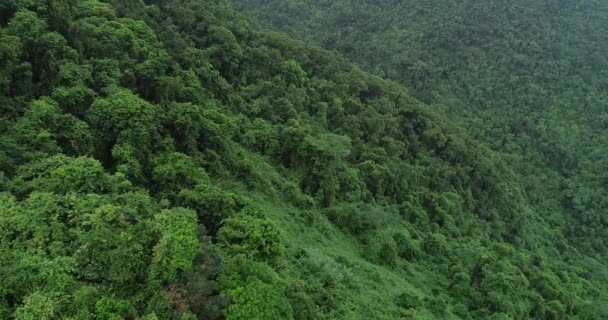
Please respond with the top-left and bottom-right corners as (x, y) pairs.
(234, 0), (608, 263)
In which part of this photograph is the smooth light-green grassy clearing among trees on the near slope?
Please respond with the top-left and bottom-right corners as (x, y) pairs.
(252, 194), (446, 319)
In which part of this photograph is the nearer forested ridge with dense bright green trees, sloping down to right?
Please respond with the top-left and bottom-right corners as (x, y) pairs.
(0, 0), (608, 319)
